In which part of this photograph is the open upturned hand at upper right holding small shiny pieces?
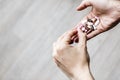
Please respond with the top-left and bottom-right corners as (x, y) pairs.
(77, 0), (120, 39)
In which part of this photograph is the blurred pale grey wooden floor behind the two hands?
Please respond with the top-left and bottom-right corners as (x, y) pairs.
(0, 0), (120, 80)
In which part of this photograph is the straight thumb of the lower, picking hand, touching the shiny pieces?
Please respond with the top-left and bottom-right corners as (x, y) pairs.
(78, 29), (87, 46)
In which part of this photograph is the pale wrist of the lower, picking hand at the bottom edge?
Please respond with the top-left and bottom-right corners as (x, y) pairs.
(72, 66), (94, 80)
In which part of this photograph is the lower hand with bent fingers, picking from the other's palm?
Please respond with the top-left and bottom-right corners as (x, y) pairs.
(53, 29), (93, 80)
